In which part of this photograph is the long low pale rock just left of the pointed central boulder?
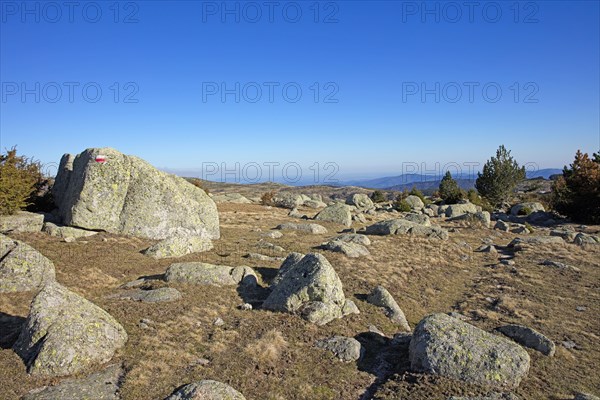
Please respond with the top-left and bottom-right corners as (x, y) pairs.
(165, 262), (258, 286)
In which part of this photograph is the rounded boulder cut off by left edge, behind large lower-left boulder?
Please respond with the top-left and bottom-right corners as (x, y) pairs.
(0, 234), (55, 293)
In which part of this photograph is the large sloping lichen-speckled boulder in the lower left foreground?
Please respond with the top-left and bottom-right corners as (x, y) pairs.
(13, 282), (127, 376)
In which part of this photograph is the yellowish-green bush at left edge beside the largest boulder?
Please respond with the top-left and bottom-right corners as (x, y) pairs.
(0, 147), (44, 215)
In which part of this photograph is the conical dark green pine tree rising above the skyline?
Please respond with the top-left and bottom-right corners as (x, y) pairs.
(475, 145), (525, 206)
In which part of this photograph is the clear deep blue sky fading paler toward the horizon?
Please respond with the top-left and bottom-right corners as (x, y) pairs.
(0, 1), (600, 183)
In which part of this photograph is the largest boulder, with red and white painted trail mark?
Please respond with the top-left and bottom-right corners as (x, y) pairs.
(53, 148), (220, 239)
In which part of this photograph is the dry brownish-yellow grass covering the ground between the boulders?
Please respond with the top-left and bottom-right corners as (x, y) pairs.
(0, 198), (600, 400)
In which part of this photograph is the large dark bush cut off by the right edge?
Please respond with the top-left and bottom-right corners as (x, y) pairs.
(552, 150), (600, 224)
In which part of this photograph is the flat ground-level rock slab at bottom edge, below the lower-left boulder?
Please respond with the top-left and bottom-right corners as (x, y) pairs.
(22, 364), (124, 400)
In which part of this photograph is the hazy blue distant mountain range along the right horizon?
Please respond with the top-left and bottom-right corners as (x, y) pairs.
(336, 168), (562, 192)
